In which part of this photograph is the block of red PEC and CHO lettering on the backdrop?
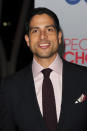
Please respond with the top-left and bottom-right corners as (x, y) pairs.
(64, 38), (87, 64)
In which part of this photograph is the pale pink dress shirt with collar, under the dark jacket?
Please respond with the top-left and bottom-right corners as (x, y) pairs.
(32, 55), (63, 121)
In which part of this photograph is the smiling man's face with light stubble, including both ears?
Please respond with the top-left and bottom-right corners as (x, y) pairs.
(25, 14), (62, 59)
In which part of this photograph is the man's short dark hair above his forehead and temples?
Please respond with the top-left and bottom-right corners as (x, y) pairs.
(25, 7), (60, 34)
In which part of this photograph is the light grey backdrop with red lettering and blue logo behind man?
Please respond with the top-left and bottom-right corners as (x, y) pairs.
(35, 0), (87, 66)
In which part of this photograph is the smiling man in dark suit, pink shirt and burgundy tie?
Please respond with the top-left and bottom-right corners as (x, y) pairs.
(1, 8), (87, 131)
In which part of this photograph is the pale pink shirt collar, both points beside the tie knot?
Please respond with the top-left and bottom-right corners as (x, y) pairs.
(32, 55), (63, 77)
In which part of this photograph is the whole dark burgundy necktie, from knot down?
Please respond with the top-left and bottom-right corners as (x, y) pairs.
(42, 68), (57, 131)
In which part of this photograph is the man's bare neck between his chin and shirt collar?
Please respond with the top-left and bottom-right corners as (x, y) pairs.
(34, 54), (57, 68)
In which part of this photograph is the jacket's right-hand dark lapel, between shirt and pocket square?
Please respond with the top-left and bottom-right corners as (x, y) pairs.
(57, 61), (82, 130)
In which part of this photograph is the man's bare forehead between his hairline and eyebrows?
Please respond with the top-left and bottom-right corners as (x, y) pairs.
(29, 14), (54, 27)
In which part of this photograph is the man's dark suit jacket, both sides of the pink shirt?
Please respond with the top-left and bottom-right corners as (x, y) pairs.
(0, 60), (87, 131)
